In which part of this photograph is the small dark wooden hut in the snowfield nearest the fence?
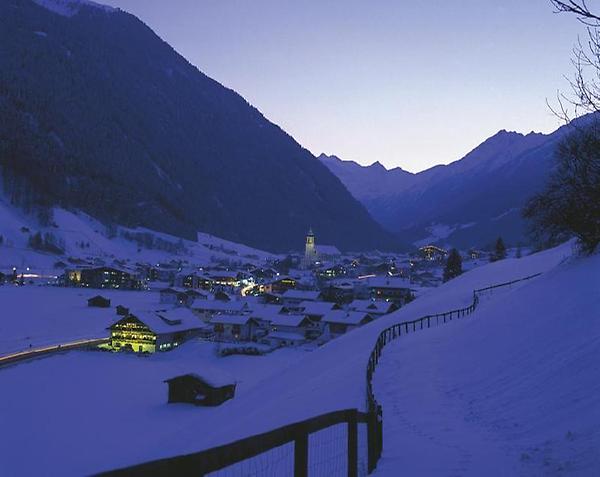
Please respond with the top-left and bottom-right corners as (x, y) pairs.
(165, 373), (235, 406)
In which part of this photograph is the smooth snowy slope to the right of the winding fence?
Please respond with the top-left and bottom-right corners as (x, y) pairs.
(375, 244), (600, 476)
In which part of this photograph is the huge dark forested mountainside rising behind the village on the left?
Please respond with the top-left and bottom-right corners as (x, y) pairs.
(0, 0), (398, 252)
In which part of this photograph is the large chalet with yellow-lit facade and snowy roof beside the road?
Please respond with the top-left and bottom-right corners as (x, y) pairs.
(108, 308), (205, 353)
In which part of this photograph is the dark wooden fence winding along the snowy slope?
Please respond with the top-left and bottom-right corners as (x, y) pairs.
(99, 273), (540, 477)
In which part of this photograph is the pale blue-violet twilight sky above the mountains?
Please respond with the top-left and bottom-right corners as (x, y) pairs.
(99, 0), (585, 172)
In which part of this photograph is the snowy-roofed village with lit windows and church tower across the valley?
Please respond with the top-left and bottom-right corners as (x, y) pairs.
(0, 229), (496, 366)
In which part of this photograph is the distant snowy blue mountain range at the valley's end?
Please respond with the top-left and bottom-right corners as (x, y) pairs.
(320, 122), (569, 248)
